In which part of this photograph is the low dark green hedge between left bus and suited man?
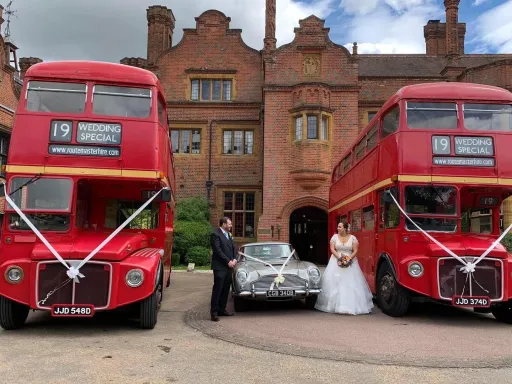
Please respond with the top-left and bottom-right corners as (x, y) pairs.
(173, 221), (212, 255)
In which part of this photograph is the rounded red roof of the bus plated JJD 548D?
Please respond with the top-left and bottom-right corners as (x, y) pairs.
(25, 61), (159, 86)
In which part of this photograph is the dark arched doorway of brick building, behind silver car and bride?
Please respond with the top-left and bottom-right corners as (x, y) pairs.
(290, 206), (329, 265)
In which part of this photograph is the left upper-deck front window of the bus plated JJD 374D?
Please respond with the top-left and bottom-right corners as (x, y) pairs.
(407, 101), (457, 129)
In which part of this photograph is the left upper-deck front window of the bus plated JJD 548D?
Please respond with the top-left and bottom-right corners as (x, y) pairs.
(27, 81), (87, 113)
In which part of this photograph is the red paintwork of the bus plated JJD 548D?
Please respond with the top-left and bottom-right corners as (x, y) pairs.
(0, 61), (175, 309)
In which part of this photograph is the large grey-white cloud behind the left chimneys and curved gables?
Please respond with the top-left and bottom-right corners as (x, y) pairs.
(11, 0), (339, 62)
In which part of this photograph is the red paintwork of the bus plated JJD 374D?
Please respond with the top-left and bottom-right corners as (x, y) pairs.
(328, 83), (512, 300)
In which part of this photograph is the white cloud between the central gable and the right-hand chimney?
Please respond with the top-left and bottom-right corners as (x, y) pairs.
(341, 0), (444, 54)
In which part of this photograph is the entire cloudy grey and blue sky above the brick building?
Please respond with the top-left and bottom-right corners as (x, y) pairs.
(4, 0), (512, 62)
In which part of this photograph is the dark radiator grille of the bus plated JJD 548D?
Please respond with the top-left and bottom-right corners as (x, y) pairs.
(36, 261), (112, 309)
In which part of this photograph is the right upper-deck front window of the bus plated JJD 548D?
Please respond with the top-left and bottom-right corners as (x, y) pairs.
(92, 85), (151, 118)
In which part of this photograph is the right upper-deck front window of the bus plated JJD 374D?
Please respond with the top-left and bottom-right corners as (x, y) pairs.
(463, 104), (512, 131)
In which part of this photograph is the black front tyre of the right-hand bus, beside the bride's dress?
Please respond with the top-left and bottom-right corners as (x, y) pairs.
(377, 262), (411, 317)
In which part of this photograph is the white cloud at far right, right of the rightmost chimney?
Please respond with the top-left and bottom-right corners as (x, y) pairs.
(468, 1), (512, 53)
